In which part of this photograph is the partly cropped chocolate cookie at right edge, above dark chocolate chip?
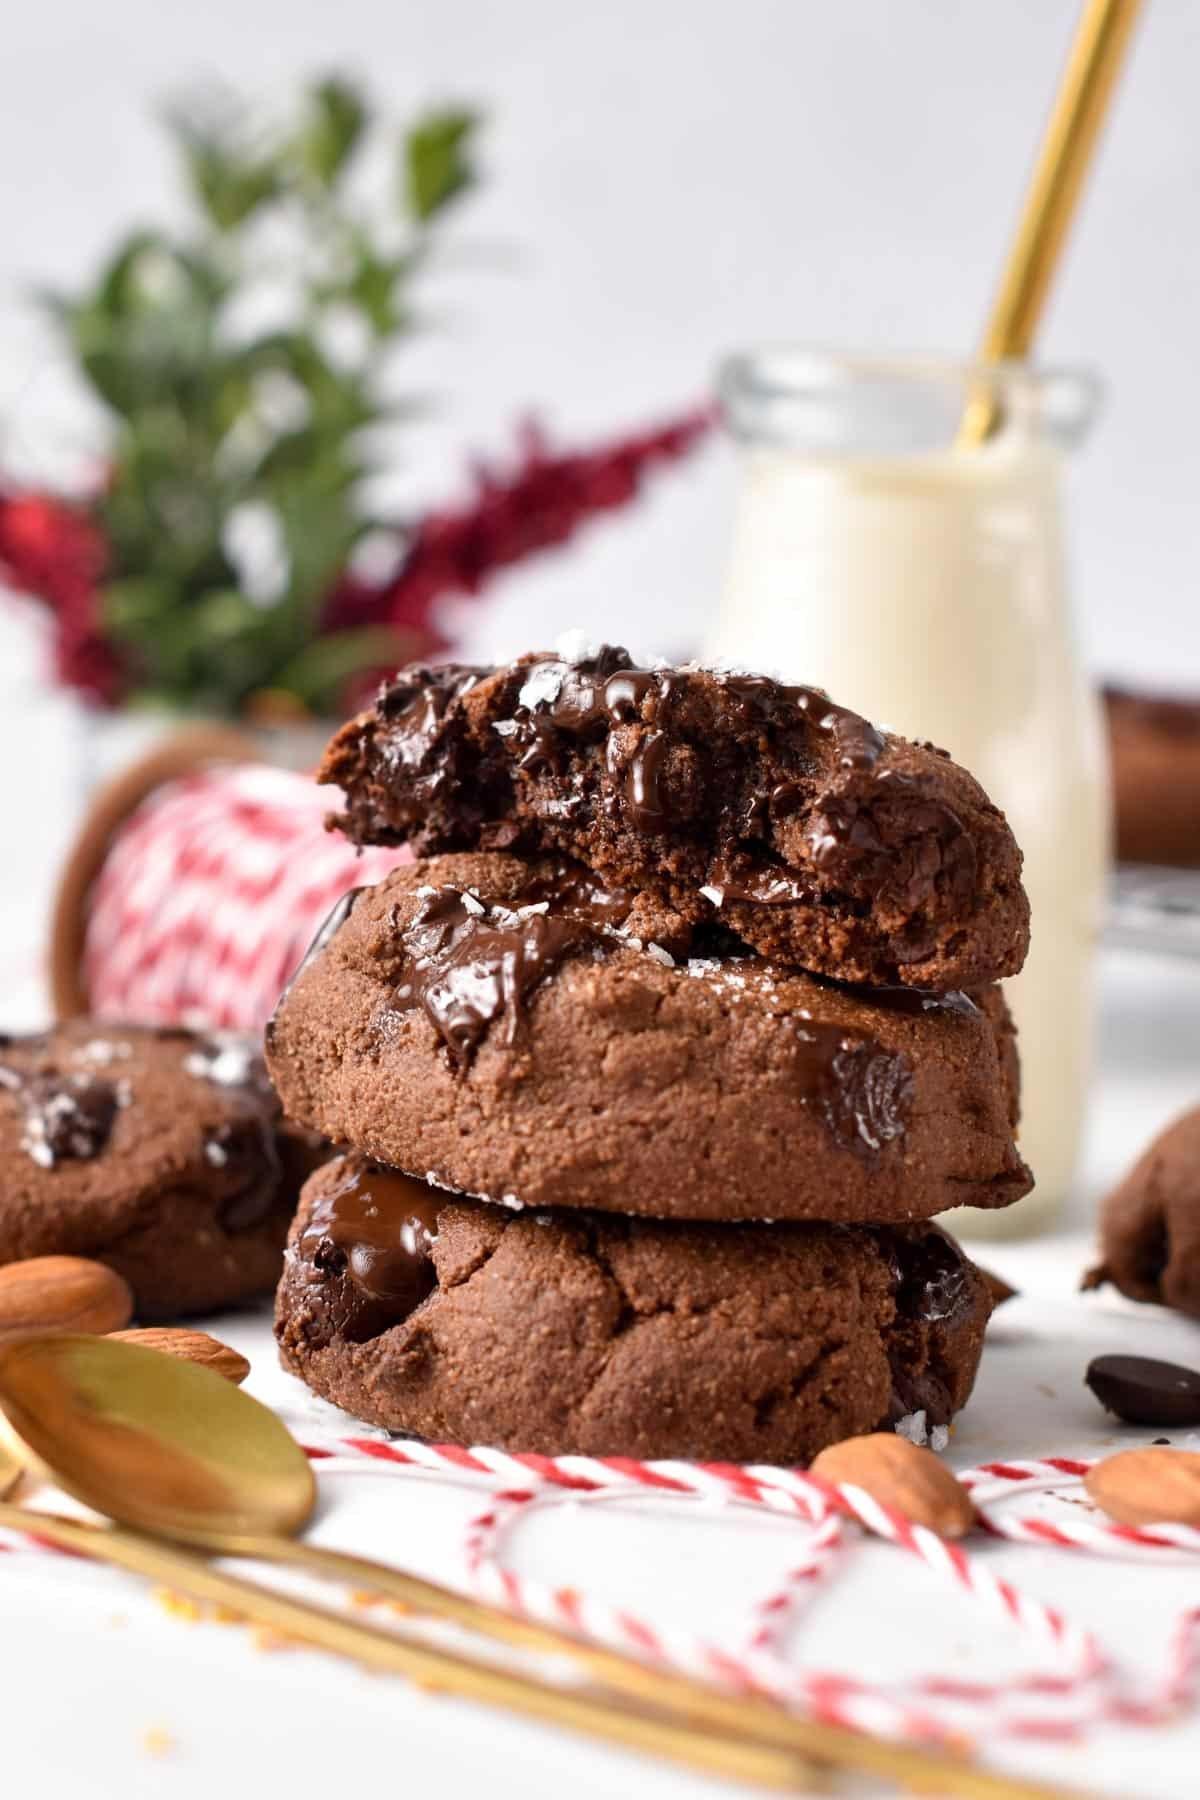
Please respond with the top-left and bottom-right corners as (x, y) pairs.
(1083, 1107), (1200, 1319)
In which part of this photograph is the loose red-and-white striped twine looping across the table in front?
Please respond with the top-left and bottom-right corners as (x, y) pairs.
(293, 1438), (1200, 1742)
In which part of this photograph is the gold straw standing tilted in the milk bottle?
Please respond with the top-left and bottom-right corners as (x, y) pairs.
(957, 0), (1142, 446)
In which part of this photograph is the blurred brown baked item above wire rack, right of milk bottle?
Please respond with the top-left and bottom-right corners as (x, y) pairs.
(1105, 688), (1200, 869)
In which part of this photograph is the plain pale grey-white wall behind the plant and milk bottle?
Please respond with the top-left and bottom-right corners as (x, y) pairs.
(0, 0), (1200, 686)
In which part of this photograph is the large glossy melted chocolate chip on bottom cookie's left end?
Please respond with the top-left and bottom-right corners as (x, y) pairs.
(300, 1166), (443, 1343)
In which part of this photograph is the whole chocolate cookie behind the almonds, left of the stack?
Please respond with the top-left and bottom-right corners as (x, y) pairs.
(0, 1019), (327, 1321)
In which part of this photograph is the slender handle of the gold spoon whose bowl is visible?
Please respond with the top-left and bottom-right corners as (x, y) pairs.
(237, 1535), (1070, 1800)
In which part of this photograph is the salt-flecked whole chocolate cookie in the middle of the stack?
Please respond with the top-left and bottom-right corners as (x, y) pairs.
(266, 851), (1031, 1222)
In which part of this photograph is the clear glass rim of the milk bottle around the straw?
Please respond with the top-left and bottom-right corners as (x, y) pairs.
(718, 344), (1103, 450)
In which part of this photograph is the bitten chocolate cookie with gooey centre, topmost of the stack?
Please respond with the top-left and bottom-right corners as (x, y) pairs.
(318, 648), (1029, 990)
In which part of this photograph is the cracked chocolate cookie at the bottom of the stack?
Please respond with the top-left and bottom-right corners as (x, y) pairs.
(275, 1156), (991, 1463)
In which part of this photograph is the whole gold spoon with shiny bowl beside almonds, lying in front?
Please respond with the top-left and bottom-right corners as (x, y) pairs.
(0, 1336), (1086, 1800)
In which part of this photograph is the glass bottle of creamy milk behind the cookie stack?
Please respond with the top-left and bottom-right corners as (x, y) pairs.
(705, 351), (1108, 1235)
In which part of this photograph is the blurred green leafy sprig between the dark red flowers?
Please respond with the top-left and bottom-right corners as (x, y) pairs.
(47, 77), (479, 713)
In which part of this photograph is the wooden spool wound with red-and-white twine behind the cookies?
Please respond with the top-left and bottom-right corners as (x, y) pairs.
(50, 727), (408, 1031)
